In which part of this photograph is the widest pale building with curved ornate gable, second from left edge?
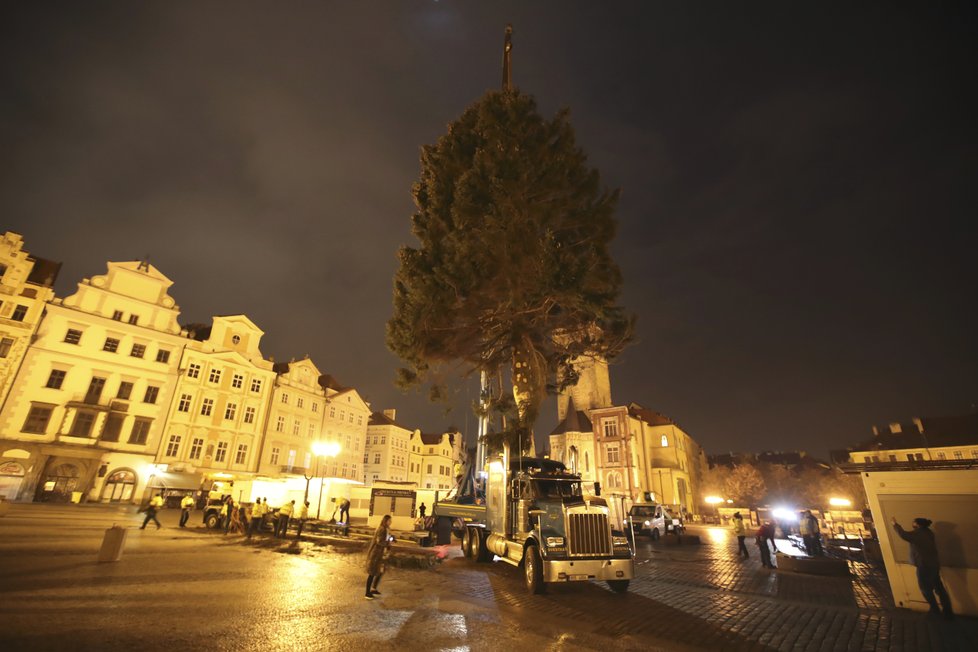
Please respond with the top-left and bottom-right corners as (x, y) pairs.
(0, 262), (186, 501)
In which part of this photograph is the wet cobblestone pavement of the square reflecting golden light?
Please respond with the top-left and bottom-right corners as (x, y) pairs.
(0, 506), (978, 652)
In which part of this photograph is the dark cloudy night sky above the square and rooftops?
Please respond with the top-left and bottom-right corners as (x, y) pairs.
(0, 0), (978, 456)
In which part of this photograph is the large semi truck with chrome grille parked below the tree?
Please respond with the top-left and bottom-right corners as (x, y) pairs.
(432, 450), (635, 593)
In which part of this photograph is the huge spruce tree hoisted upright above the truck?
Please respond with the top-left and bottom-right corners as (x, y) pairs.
(387, 90), (632, 450)
